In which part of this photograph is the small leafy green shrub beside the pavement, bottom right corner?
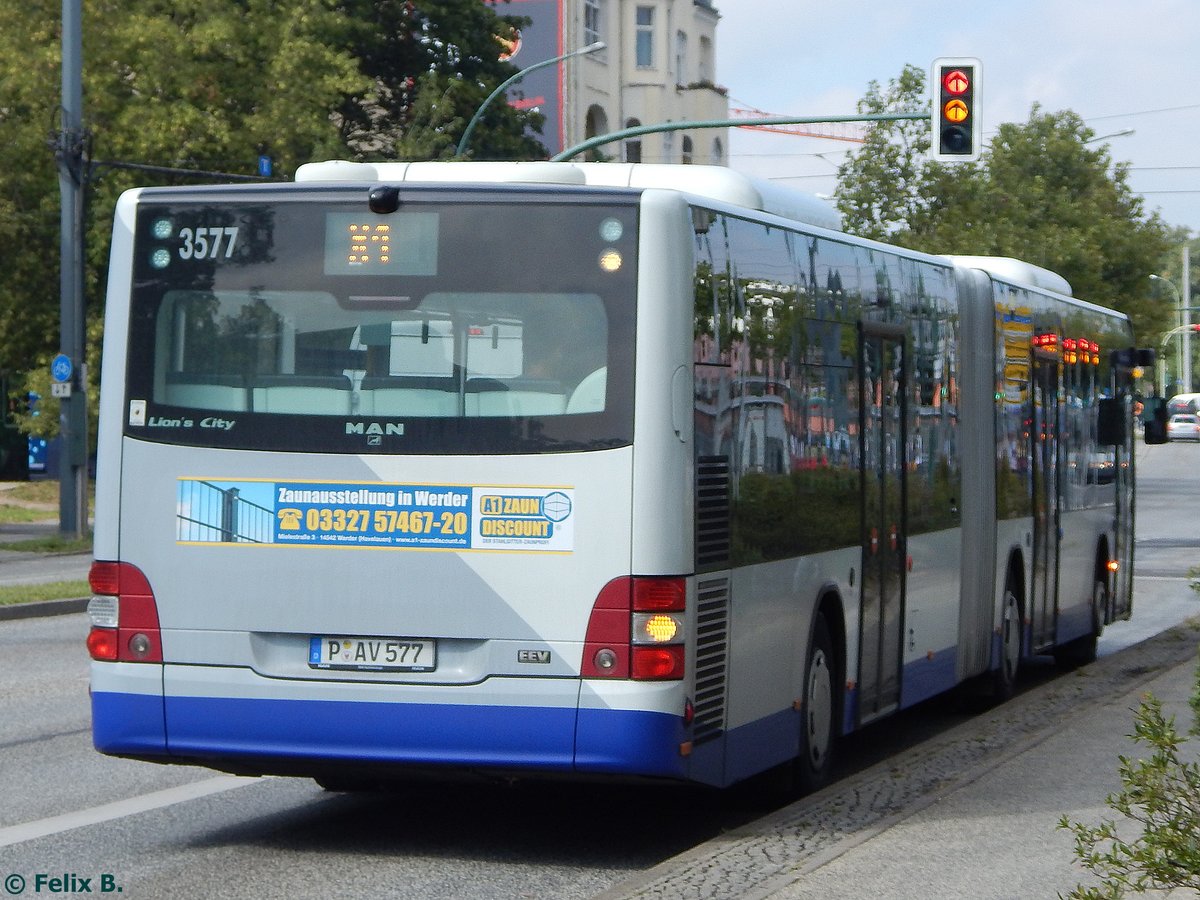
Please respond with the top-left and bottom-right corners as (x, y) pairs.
(1058, 667), (1200, 900)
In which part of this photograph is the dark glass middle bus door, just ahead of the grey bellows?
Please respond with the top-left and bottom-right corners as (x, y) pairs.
(1028, 348), (1062, 649)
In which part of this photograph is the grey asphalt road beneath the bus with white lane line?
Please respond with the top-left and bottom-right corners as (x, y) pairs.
(0, 445), (1200, 898)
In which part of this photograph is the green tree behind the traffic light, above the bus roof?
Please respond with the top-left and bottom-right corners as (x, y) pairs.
(836, 66), (1170, 342)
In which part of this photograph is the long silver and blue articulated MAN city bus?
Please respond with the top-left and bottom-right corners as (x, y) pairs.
(88, 161), (1134, 788)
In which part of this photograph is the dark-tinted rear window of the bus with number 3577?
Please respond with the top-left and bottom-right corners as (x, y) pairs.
(126, 194), (636, 454)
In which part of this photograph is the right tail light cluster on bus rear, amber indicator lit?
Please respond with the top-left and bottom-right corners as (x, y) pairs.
(581, 577), (688, 680)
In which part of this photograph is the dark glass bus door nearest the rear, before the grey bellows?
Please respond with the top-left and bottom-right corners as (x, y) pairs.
(858, 323), (908, 722)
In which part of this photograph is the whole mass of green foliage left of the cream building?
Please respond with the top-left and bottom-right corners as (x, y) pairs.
(0, 0), (546, 437)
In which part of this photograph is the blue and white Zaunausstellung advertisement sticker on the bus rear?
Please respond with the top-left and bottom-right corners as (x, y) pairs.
(175, 478), (575, 553)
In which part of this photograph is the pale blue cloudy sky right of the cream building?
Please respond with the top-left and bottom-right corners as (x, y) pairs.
(715, 0), (1200, 234)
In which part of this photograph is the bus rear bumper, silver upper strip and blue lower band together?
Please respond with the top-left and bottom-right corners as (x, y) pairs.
(92, 664), (686, 778)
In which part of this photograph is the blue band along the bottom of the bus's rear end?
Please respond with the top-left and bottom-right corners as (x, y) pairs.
(92, 692), (688, 778)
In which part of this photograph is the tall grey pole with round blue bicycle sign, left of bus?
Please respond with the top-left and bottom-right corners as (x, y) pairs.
(53, 0), (88, 538)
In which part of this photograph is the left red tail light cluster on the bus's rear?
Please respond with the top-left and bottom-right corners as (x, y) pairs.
(88, 560), (162, 662)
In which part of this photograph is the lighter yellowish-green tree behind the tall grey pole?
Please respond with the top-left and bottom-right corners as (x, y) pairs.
(0, 0), (365, 431)
